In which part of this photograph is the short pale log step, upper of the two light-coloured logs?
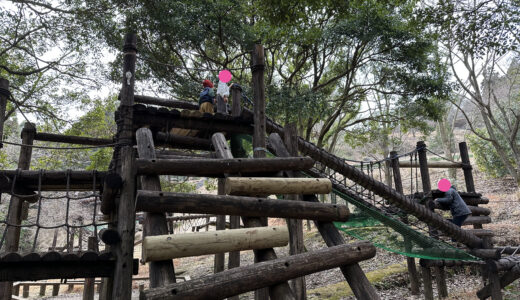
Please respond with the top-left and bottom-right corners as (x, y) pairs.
(226, 177), (332, 195)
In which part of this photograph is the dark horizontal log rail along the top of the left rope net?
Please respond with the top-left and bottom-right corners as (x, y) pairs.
(0, 170), (106, 192)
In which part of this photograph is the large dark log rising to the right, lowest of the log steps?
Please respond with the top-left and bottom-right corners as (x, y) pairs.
(140, 242), (375, 300)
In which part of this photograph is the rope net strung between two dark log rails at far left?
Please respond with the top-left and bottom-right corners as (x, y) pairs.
(0, 170), (109, 255)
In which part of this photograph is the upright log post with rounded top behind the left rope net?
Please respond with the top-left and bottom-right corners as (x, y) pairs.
(0, 122), (36, 300)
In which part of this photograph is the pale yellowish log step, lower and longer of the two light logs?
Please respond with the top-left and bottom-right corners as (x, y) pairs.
(143, 226), (289, 262)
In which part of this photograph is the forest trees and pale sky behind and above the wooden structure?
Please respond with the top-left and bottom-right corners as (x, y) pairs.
(0, 0), (520, 190)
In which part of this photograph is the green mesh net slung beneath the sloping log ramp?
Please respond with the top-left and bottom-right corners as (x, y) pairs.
(333, 190), (479, 261)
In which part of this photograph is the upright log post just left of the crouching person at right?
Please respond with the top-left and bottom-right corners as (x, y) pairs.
(417, 141), (448, 299)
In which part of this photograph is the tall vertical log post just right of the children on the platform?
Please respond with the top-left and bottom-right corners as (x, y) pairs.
(251, 44), (269, 300)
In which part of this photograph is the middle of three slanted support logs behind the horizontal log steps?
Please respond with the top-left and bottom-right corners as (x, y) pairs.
(211, 133), (294, 299)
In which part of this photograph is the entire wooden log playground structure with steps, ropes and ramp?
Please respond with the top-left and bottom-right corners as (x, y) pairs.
(0, 34), (520, 300)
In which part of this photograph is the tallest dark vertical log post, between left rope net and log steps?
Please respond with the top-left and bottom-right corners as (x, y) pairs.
(112, 34), (137, 299)
